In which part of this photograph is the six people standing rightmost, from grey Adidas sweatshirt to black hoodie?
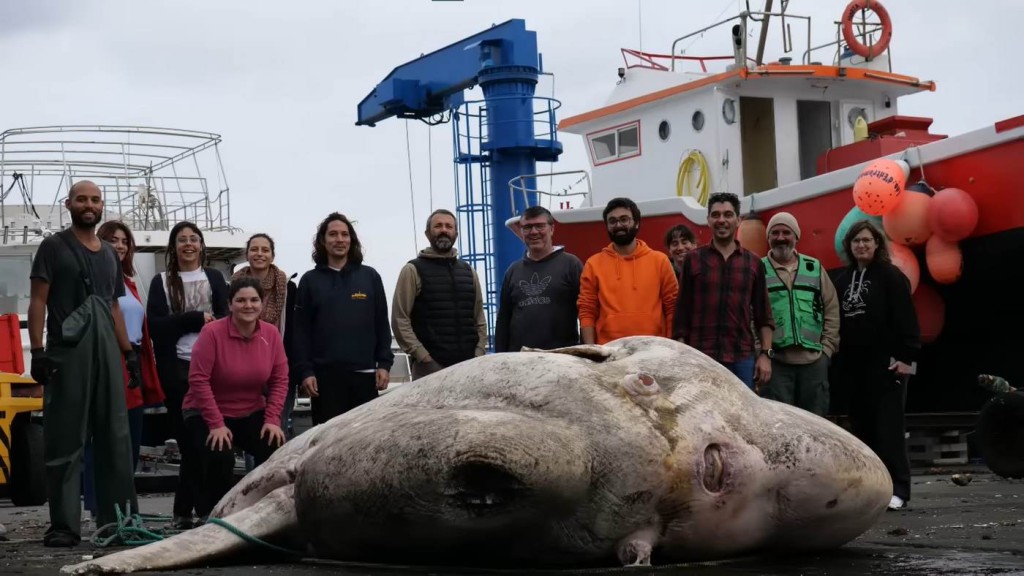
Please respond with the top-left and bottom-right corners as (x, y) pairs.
(495, 193), (921, 509)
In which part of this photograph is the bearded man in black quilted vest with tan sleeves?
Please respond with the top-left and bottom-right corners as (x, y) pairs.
(391, 209), (487, 380)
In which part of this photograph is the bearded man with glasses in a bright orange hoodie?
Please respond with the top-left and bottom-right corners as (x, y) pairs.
(578, 198), (679, 344)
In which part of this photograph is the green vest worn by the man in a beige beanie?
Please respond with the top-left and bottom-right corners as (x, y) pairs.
(761, 254), (825, 351)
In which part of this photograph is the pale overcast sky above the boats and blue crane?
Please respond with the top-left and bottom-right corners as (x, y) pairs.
(0, 0), (1024, 301)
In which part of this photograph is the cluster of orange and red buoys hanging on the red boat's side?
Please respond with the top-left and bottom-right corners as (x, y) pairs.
(836, 159), (978, 342)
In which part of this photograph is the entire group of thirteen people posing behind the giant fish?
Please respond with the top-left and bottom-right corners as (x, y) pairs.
(29, 180), (919, 546)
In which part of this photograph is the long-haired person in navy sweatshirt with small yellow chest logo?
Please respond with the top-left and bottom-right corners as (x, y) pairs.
(296, 212), (394, 425)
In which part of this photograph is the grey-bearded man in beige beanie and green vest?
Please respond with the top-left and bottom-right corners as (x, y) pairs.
(762, 212), (840, 416)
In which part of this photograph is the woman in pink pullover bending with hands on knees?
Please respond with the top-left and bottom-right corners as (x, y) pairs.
(181, 278), (288, 522)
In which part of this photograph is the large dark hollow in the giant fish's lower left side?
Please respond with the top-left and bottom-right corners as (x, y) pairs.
(444, 461), (527, 516)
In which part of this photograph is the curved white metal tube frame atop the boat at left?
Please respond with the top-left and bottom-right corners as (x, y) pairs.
(0, 125), (234, 239)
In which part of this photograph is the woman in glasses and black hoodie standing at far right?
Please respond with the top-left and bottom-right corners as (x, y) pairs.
(834, 220), (921, 509)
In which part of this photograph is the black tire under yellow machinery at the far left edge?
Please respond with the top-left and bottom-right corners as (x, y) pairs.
(10, 412), (46, 506)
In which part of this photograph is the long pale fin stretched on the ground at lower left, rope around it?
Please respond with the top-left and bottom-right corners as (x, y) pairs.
(60, 484), (299, 574)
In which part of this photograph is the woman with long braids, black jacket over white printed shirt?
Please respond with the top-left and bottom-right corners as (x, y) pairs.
(146, 218), (227, 530)
